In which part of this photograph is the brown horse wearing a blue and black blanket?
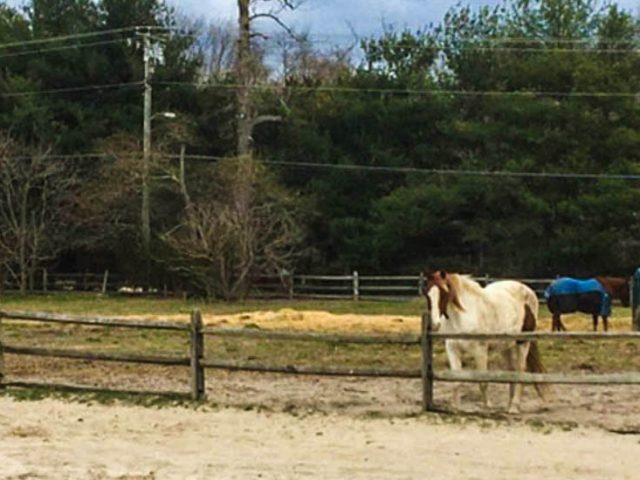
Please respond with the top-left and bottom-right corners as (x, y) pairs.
(544, 277), (629, 332)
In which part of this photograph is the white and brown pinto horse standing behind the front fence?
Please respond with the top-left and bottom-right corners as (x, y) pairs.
(423, 271), (544, 413)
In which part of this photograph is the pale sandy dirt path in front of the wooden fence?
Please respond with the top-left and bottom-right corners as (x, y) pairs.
(0, 397), (640, 480)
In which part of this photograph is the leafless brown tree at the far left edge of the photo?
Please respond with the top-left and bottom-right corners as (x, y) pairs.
(0, 133), (76, 293)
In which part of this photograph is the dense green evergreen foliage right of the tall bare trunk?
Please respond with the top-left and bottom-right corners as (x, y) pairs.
(274, 0), (639, 275)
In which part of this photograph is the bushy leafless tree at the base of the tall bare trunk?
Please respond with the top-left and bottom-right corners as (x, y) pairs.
(164, 157), (303, 299)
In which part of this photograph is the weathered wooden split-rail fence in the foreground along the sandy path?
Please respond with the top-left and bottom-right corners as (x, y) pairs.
(0, 310), (640, 411)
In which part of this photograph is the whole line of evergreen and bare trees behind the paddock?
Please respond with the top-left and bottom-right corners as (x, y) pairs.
(0, 0), (640, 298)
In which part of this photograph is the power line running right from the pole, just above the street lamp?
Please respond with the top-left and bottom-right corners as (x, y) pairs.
(154, 81), (640, 98)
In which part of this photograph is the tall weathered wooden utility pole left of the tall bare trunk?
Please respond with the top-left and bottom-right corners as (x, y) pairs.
(140, 30), (151, 261)
